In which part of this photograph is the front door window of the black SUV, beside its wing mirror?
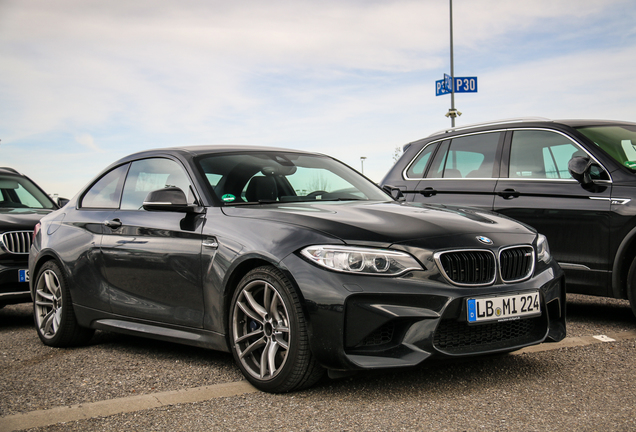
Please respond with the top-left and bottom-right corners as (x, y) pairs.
(509, 130), (608, 180)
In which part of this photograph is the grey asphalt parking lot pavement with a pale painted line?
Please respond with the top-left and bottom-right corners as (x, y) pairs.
(0, 295), (636, 431)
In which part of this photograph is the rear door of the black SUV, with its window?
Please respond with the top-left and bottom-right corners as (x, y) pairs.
(409, 132), (503, 210)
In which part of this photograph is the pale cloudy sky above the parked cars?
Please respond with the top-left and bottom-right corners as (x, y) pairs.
(0, 0), (636, 198)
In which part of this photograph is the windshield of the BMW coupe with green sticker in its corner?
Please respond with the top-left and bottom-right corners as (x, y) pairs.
(198, 152), (390, 205)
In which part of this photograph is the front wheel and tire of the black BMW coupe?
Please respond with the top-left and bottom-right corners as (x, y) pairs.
(229, 266), (325, 393)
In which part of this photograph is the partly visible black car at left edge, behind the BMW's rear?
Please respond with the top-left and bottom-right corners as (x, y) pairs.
(0, 167), (58, 308)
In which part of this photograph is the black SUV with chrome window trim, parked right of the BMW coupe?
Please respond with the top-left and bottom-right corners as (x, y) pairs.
(382, 118), (636, 314)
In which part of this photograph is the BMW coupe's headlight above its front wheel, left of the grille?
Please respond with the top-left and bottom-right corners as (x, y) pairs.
(300, 246), (423, 276)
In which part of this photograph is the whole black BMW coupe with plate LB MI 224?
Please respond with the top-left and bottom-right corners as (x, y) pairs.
(29, 146), (566, 392)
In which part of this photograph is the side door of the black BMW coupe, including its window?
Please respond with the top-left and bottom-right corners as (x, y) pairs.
(101, 158), (204, 328)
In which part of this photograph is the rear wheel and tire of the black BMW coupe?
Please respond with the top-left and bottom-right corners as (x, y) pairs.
(33, 261), (95, 348)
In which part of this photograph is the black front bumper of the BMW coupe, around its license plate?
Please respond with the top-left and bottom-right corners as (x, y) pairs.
(287, 256), (566, 370)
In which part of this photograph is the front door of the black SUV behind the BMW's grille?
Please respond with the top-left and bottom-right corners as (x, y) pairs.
(494, 129), (612, 294)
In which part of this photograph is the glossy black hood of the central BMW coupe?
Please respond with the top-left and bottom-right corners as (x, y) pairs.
(223, 201), (536, 248)
